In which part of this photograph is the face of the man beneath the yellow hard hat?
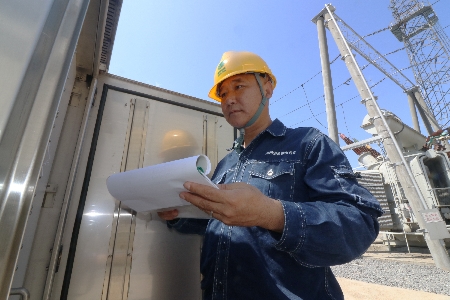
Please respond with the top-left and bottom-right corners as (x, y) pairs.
(219, 74), (271, 128)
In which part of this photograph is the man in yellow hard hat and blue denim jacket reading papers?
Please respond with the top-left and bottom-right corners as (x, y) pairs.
(160, 52), (382, 300)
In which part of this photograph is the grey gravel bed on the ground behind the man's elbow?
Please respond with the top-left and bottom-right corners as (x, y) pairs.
(331, 257), (450, 296)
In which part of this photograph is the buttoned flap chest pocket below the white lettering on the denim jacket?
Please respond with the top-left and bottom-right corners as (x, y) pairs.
(247, 161), (295, 200)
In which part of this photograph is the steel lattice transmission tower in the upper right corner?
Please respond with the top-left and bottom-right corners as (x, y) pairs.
(389, 0), (450, 127)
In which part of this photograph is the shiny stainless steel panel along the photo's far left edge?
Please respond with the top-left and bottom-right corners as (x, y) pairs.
(0, 0), (88, 299)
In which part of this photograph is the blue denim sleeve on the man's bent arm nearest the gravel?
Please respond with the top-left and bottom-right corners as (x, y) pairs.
(275, 133), (383, 267)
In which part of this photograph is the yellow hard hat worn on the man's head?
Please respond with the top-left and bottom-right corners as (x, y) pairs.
(208, 51), (277, 102)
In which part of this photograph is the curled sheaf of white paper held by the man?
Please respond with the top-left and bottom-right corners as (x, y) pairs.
(106, 155), (218, 218)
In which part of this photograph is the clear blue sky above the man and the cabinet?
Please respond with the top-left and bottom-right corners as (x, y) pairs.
(109, 0), (450, 166)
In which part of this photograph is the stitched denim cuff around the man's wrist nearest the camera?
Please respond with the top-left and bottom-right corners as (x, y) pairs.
(275, 200), (306, 252)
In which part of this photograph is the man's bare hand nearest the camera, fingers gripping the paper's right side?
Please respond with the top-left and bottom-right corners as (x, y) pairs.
(180, 182), (284, 232)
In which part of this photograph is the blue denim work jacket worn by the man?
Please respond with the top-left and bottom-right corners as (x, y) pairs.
(169, 120), (383, 300)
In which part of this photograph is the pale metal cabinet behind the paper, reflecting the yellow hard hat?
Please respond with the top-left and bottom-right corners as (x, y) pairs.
(66, 75), (234, 299)
